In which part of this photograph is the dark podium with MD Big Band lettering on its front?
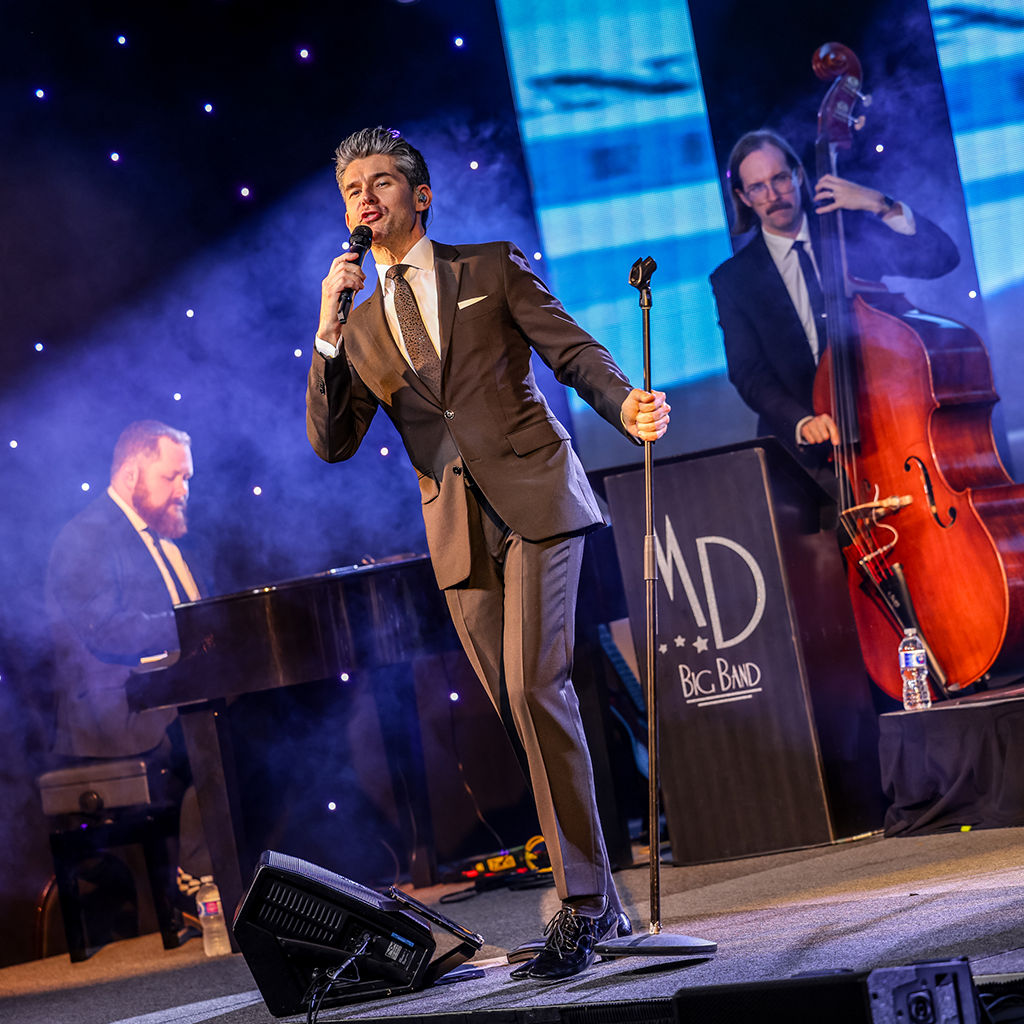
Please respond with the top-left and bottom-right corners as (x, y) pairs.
(604, 438), (884, 864)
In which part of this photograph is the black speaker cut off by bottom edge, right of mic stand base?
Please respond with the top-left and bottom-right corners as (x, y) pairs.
(672, 958), (982, 1024)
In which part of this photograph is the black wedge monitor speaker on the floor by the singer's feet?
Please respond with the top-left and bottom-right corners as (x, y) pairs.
(233, 851), (483, 1017)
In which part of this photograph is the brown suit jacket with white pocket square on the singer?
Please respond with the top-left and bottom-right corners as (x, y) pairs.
(306, 242), (631, 589)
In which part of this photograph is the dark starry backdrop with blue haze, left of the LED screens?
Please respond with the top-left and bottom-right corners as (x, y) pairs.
(0, 0), (552, 964)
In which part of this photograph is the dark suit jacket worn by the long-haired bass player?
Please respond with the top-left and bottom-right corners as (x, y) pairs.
(711, 211), (959, 465)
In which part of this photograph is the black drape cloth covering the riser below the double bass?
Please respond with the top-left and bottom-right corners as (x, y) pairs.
(879, 697), (1024, 836)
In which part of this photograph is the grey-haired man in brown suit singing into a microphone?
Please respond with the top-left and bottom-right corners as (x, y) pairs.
(306, 128), (670, 979)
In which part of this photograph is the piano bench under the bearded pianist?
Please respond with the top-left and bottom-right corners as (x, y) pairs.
(39, 760), (179, 963)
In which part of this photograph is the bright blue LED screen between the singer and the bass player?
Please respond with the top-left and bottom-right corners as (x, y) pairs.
(498, 0), (732, 428)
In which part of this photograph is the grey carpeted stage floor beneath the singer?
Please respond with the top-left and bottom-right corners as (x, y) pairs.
(0, 828), (1024, 1024)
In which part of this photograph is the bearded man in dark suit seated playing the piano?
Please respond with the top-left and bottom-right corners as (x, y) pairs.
(46, 420), (211, 912)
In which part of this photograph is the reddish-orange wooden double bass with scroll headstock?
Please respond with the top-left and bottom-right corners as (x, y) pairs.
(813, 43), (1024, 698)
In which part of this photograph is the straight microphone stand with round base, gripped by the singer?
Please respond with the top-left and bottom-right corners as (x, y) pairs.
(595, 256), (718, 957)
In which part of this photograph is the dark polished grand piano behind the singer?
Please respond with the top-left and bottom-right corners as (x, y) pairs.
(127, 555), (466, 937)
